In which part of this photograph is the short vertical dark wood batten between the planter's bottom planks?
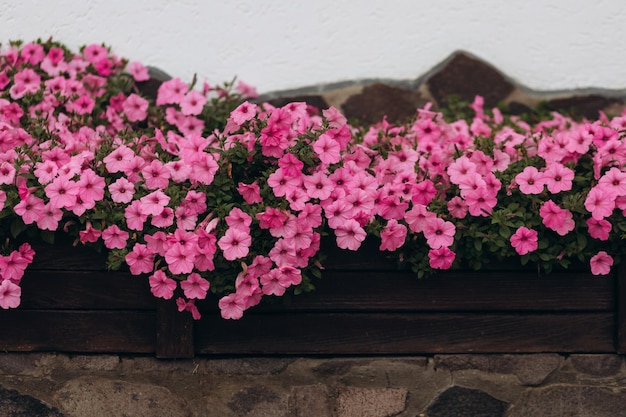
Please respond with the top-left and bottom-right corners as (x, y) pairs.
(156, 299), (194, 359)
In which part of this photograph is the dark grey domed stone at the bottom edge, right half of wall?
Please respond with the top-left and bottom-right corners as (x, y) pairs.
(426, 386), (508, 417)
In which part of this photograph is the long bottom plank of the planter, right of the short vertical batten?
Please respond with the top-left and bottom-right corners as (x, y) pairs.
(195, 313), (615, 355)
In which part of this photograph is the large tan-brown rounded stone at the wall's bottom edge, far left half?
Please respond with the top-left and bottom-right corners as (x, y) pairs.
(56, 377), (190, 417)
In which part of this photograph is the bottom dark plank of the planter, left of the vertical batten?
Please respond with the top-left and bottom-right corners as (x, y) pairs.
(0, 310), (156, 353)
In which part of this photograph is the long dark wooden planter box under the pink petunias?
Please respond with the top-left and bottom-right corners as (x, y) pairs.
(0, 240), (626, 358)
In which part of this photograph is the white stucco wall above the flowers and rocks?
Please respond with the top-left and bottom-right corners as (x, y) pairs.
(0, 0), (626, 93)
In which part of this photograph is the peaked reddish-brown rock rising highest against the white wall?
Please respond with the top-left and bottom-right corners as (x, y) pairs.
(426, 52), (515, 107)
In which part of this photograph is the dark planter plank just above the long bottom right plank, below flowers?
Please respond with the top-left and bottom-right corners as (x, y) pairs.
(203, 271), (616, 312)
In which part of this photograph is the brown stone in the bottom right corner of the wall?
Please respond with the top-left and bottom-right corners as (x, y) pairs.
(508, 385), (626, 417)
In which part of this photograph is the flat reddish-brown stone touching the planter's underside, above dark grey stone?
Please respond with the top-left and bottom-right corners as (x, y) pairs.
(435, 353), (563, 385)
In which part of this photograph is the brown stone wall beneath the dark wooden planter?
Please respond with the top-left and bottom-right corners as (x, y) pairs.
(0, 353), (626, 417)
